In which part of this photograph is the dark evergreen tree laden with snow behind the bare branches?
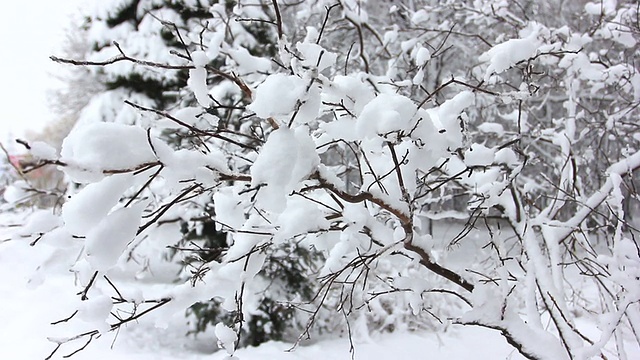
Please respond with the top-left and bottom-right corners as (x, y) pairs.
(44, 1), (322, 345)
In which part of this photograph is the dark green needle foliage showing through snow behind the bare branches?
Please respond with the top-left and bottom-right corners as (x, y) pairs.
(94, 0), (319, 345)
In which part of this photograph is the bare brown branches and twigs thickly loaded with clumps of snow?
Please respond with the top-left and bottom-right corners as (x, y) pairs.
(5, 0), (640, 359)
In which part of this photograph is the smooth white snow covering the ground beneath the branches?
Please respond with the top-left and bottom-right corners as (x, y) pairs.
(0, 216), (522, 360)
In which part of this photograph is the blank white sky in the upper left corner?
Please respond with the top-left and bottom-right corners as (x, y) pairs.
(0, 0), (89, 145)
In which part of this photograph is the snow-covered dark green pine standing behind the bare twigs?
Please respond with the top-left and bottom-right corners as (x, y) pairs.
(74, 0), (317, 345)
